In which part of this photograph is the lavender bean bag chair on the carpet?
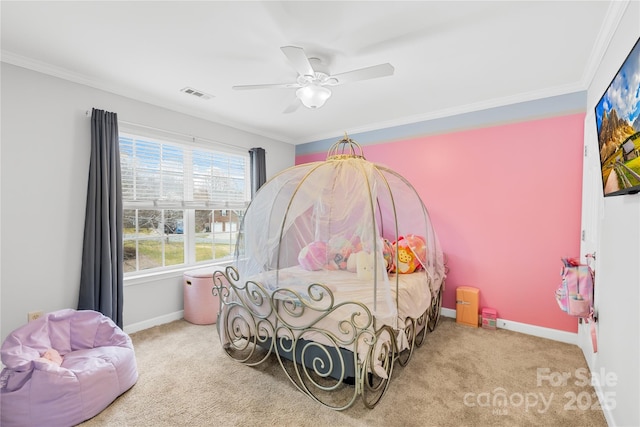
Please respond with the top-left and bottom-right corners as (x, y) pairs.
(0, 309), (138, 427)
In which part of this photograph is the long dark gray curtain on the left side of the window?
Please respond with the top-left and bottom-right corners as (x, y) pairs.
(78, 108), (123, 328)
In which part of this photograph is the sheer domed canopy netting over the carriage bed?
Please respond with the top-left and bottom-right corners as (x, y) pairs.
(235, 135), (445, 327)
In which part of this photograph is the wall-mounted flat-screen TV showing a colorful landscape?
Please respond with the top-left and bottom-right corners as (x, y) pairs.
(596, 38), (640, 197)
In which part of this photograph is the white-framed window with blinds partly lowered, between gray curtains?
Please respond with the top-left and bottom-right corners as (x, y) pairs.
(120, 134), (251, 275)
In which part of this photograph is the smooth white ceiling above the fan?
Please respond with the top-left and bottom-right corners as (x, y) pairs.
(0, 0), (627, 144)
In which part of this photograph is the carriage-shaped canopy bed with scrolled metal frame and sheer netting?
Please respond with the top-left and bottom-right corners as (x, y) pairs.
(213, 134), (446, 410)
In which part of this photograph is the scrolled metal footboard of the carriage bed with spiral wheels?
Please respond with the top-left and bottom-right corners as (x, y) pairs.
(213, 266), (396, 410)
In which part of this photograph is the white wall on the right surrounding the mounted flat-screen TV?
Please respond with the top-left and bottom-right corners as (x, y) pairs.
(579, 1), (640, 426)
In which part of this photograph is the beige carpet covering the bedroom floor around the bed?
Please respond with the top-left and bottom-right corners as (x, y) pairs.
(82, 318), (606, 427)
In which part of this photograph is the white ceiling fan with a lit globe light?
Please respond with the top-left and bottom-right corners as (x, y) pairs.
(233, 46), (394, 113)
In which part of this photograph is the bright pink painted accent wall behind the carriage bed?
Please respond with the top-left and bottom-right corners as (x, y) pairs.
(296, 113), (584, 332)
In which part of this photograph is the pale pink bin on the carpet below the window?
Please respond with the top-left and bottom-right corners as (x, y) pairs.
(184, 267), (220, 325)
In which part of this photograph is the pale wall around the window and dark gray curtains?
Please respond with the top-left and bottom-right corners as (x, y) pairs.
(0, 63), (295, 340)
